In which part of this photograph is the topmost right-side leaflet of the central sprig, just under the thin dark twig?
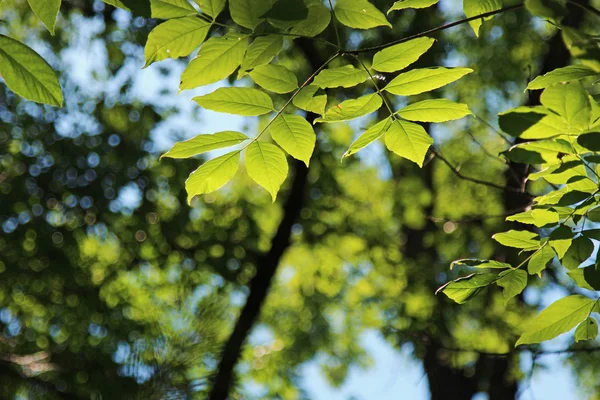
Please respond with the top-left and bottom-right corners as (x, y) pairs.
(371, 37), (435, 72)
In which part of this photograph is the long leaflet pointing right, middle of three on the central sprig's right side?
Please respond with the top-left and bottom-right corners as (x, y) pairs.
(384, 67), (473, 96)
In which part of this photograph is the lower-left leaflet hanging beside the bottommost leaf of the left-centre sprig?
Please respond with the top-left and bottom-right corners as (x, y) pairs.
(185, 151), (240, 203)
